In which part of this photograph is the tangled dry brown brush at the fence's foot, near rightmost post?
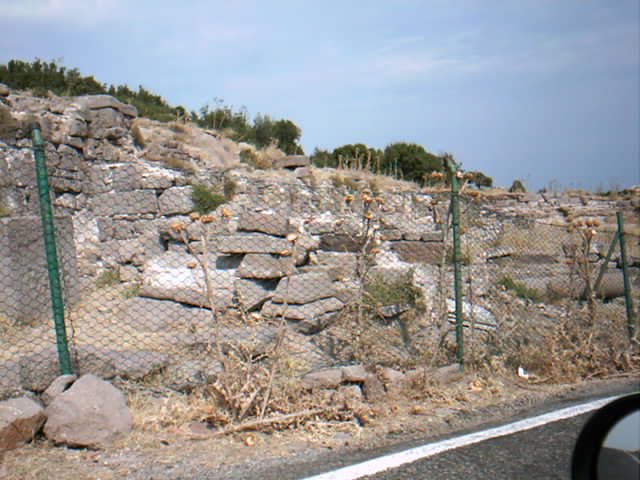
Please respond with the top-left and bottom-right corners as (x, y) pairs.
(466, 301), (640, 383)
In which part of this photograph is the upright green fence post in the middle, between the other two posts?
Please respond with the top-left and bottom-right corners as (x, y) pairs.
(445, 157), (464, 370)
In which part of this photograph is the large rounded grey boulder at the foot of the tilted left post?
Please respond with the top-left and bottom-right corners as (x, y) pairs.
(44, 374), (132, 448)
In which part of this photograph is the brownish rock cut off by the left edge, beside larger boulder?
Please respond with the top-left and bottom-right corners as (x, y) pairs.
(0, 397), (46, 454)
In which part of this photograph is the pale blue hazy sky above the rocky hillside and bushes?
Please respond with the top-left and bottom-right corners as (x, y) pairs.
(0, 0), (640, 190)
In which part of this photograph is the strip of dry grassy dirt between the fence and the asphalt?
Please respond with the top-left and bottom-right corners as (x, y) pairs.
(0, 374), (640, 480)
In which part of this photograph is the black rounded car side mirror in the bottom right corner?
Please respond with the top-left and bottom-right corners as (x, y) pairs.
(571, 393), (640, 480)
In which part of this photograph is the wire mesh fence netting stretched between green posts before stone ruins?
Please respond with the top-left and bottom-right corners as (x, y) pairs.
(0, 141), (639, 418)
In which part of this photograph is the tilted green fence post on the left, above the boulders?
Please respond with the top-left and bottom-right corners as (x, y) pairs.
(31, 123), (73, 375)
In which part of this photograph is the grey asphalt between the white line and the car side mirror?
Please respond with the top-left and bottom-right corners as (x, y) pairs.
(364, 414), (591, 480)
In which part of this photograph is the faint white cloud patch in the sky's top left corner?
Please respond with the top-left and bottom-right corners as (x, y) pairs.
(0, 0), (121, 27)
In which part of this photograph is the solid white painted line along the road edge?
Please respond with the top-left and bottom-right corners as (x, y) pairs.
(302, 396), (619, 480)
